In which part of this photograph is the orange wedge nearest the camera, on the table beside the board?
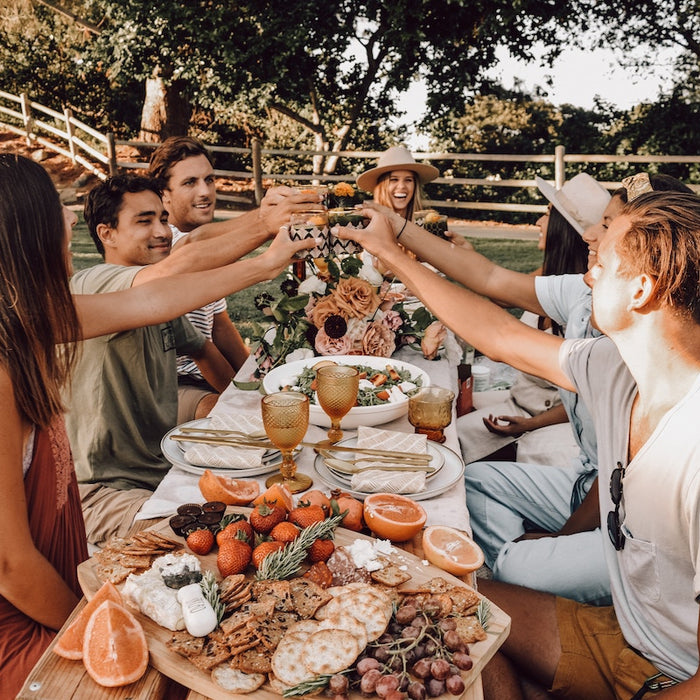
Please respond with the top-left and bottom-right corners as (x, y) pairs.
(83, 600), (148, 688)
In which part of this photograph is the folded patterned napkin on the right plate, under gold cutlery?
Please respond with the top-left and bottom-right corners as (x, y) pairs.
(350, 426), (428, 493)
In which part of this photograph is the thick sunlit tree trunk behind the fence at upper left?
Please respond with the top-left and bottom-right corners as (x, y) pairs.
(139, 71), (191, 143)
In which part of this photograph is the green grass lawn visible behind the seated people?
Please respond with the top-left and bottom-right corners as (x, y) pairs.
(71, 214), (542, 338)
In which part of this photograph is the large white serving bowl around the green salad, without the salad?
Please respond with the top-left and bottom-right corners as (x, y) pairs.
(263, 355), (430, 430)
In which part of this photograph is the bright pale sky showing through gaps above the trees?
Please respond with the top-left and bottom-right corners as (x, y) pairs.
(399, 43), (675, 150)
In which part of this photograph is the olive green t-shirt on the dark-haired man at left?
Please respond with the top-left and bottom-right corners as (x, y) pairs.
(66, 264), (205, 489)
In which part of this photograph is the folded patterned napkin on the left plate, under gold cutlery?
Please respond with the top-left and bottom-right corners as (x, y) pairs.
(185, 413), (266, 469)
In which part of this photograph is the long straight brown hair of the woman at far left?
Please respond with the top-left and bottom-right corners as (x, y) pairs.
(0, 153), (80, 427)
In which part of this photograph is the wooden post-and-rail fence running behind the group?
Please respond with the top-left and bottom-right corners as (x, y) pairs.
(0, 91), (700, 213)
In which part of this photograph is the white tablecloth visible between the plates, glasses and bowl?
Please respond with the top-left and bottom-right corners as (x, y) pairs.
(136, 348), (471, 532)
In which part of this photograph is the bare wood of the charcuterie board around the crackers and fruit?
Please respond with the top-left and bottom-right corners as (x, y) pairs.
(78, 508), (510, 700)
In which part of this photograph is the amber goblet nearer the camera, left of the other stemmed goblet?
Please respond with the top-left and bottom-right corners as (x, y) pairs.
(261, 391), (313, 493)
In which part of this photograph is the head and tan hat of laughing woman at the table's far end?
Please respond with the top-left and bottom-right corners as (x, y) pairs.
(357, 146), (440, 221)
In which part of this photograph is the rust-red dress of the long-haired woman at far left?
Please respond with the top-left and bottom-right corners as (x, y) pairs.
(0, 417), (88, 699)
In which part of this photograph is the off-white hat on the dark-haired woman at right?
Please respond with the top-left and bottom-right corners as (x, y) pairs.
(535, 173), (610, 234)
